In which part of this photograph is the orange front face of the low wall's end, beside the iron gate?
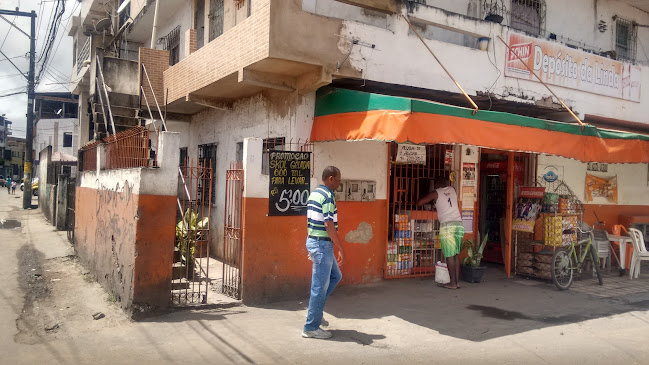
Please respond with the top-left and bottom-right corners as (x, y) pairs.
(133, 195), (176, 307)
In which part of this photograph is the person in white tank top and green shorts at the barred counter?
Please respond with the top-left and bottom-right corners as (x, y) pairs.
(417, 178), (464, 289)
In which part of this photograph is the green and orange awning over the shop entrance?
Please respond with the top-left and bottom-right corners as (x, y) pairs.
(311, 87), (649, 163)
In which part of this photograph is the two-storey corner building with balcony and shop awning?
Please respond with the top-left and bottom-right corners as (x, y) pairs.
(69, 0), (649, 302)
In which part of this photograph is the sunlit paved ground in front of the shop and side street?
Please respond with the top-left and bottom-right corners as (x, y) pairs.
(0, 190), (649, 364)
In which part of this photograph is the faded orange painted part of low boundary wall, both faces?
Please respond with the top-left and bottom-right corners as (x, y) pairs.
(75, 188), (176, 309)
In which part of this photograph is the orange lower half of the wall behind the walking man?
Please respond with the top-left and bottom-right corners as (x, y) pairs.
(242, 198), (387, 303)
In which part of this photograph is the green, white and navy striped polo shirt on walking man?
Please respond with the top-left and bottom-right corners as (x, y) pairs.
(306, 185), (338, 237)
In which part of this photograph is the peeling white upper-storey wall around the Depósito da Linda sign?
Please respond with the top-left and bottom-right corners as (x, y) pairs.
(306, 0), (649, 122)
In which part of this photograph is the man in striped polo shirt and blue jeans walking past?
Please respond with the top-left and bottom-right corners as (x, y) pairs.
(302, 166), (343, 338)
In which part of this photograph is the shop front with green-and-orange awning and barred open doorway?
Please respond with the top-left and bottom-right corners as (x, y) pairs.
(311, 88), (649, 278)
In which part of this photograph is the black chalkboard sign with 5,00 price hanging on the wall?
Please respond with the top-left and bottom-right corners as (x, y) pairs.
(268, 151), (311, 216)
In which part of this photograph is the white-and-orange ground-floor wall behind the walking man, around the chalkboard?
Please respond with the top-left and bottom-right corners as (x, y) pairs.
(242, 139), (388, 303)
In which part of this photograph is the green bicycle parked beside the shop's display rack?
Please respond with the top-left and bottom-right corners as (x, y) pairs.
(552, 227), (604, 290)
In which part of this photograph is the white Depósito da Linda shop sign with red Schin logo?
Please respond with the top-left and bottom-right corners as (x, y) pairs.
(505, 33), (642, 103)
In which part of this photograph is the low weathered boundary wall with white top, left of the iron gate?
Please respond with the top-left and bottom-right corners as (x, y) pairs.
(75, 132), (180, 311)
